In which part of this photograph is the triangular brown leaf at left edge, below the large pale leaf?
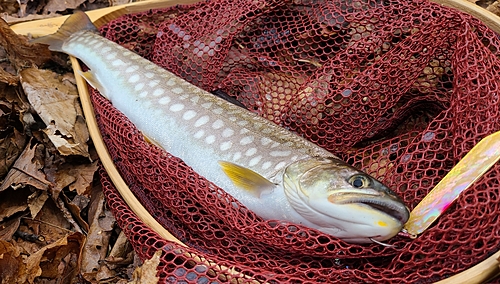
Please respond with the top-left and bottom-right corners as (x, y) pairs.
(0, 141), (52, 192)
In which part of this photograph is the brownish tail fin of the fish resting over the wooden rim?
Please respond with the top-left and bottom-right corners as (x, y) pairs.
(31, 11), (97, 52)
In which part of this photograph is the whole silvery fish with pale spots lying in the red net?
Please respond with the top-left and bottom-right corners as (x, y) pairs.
(33, 12), (409, 243)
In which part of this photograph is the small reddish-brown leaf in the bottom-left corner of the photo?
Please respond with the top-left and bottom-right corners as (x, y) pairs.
(0, 240), (27, 284)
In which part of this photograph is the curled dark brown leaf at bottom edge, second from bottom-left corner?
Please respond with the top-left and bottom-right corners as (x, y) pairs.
(26, 232), (85, 283)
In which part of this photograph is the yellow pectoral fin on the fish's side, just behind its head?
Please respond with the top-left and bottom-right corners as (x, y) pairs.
(219, 161), (276, 198)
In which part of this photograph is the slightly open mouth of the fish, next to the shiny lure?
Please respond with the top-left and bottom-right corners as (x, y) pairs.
(328, 190), (410, 224)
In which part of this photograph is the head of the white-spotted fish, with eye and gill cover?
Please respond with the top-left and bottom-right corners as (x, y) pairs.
(283, 157), (410, 243)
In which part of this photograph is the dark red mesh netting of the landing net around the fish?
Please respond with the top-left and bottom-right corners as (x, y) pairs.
(92, 0), (500, 283)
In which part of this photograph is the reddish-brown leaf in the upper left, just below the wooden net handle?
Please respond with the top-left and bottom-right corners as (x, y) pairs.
(0, 19), (51, 72)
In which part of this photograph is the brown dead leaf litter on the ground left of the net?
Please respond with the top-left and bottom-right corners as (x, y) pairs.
(0, 0), (159, 284)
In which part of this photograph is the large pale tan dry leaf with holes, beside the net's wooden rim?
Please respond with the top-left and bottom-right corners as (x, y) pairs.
(21, 68), (89, 157)
